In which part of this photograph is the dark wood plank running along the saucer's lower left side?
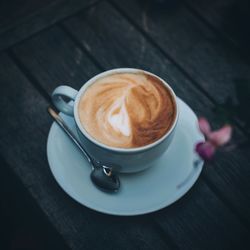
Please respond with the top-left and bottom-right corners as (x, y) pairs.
(0, 51), (171, 250)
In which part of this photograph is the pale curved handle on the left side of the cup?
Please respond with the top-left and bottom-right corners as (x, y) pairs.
(52, 85), (78, 116)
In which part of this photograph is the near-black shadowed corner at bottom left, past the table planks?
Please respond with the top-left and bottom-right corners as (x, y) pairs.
(0, 156), (69, 250)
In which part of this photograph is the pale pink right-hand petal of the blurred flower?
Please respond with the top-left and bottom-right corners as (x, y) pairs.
(208, 125), (232, 146)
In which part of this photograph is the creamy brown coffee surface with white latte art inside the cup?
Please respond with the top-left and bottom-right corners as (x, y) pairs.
(78, 73), (176, 148)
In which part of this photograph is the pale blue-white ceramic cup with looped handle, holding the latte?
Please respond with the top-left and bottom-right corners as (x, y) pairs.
(52, 68), (179, 173)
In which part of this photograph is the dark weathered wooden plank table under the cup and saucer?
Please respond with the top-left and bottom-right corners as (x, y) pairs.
(0, 0), (250, 250)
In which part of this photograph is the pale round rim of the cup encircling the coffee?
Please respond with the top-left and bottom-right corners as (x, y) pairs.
(74, 68), (179, 153)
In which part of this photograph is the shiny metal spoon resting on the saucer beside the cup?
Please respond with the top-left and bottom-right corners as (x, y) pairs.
(48, 107), (120, 192)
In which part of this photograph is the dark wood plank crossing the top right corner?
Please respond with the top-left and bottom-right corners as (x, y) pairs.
(185, 0), (250, 56)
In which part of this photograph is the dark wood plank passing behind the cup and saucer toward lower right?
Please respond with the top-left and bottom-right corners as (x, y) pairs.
(58, 0), (250, 227)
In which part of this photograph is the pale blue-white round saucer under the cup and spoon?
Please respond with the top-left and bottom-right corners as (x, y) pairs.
(47, 99), (204, 215)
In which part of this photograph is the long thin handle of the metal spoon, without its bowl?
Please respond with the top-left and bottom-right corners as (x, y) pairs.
(48, 107), (92, 164)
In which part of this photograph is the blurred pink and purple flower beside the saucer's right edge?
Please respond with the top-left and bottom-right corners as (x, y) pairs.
(195, 118), (232, 160)
